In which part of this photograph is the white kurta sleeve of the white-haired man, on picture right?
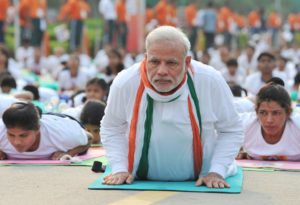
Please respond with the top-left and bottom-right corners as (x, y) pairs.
(209, 73), (244, 177)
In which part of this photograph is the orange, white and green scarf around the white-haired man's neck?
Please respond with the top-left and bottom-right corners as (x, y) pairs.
(128, 60), (202, 179)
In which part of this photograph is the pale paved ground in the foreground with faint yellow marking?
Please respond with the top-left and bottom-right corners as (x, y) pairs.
(0, 166), (300, 205)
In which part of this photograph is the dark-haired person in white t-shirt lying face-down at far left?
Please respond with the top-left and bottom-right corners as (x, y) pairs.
(0, 102), (92, 160)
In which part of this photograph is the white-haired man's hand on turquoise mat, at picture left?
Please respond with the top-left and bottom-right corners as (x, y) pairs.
(102, 172), (134, 185)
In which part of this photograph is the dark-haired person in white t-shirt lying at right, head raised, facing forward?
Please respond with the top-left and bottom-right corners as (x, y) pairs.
(237, 83), (300, 161)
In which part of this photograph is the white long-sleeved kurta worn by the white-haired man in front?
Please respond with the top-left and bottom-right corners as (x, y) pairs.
(100, 61), (243, 181)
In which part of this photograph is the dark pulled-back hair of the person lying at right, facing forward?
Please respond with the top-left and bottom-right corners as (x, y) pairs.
(256, 82), (291, 113)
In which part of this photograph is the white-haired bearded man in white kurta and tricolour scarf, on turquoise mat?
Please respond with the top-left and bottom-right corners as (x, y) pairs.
(100, 26), (243, 188)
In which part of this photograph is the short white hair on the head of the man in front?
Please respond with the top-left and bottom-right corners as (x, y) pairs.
(146, 26), (191, 56)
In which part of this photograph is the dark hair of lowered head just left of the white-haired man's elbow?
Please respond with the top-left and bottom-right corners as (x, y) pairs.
(80, 100), (105, 126)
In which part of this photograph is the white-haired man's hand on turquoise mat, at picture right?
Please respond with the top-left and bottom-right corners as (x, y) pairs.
(196, 172), (230, 188)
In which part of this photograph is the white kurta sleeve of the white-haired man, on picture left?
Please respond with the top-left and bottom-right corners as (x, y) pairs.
(100, 74), (129, 173)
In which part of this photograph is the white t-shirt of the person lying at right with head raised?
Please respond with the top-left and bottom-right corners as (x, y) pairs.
(242, 112), (300, 161)
